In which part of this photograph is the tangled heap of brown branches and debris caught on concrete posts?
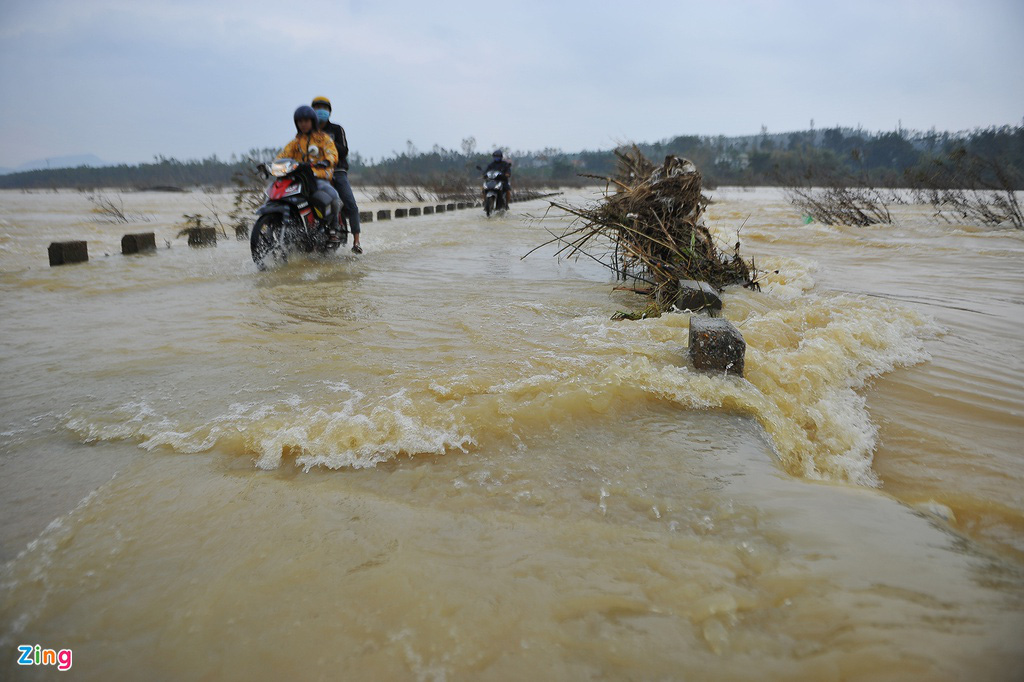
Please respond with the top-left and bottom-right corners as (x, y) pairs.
(527, 145), (760, 316)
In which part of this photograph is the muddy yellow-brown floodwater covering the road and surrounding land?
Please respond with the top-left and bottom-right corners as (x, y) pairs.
(0, 184), (1024, 680)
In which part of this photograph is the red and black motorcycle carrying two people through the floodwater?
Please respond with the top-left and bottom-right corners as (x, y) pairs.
(249, 159), (347, 270)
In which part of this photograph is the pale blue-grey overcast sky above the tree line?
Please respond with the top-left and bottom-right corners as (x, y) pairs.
(0, 0), (1024, 166)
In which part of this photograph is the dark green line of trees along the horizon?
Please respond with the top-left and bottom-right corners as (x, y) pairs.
(0, 126), (1024, 190)
